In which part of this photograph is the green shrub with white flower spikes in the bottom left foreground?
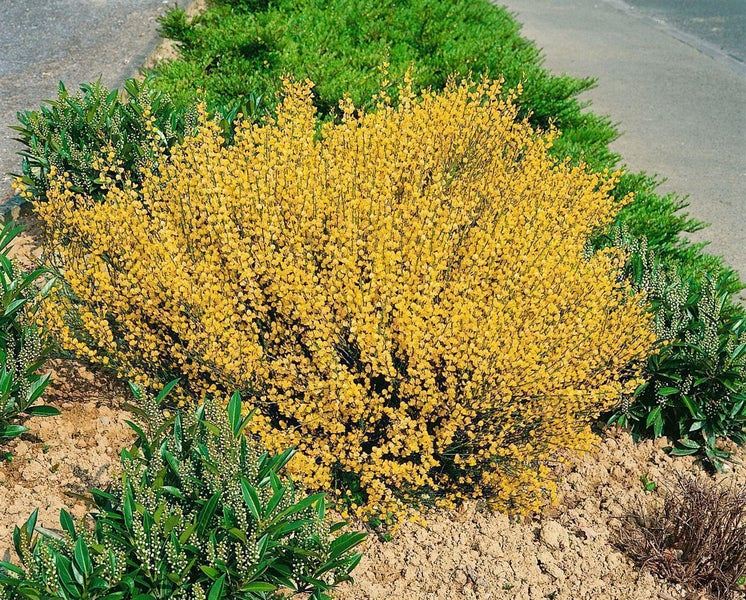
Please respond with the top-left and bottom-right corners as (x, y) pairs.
(0, 384), (365, 600)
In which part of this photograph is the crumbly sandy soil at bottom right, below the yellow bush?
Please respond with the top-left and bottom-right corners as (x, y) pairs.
(338, 430), (746, 600)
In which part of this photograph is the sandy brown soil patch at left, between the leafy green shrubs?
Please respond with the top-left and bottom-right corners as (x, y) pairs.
(0, 361), (134, 560)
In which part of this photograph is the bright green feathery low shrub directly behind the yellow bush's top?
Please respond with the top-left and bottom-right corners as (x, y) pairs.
(153, 0), (616, 158)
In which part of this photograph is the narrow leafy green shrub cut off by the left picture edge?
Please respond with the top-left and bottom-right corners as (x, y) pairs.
(0, 223), (59, 443)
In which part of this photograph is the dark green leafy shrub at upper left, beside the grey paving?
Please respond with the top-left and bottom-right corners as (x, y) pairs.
(13, 79), (190, 199)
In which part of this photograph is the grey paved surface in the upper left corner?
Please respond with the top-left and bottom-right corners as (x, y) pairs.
(0, 0), (173, 201)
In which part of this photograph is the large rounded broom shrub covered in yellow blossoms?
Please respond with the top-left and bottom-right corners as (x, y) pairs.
(38, 81), (653, 517)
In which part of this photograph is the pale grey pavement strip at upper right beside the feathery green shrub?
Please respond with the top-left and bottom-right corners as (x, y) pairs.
(500, 0), (746, 278)
